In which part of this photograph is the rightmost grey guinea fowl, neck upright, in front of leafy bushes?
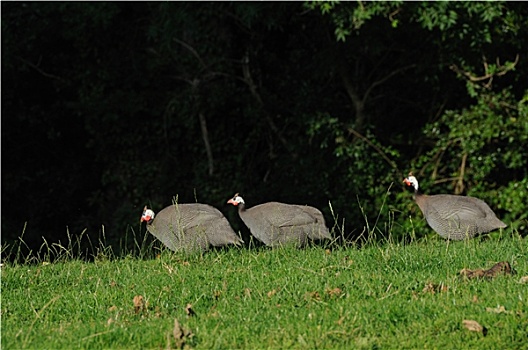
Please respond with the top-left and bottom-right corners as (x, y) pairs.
(403, 173), (507, 240)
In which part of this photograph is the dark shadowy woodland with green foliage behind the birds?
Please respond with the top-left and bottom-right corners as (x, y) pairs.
(1, 2), (528, 258)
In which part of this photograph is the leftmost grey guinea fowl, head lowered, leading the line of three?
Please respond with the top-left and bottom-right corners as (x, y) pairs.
(140, 203), (244, 251)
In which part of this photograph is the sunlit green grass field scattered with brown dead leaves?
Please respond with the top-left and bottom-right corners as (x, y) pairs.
(1, 237), (528, 349)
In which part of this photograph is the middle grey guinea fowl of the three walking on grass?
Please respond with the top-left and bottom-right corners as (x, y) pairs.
(227, 193), (332, 247)
